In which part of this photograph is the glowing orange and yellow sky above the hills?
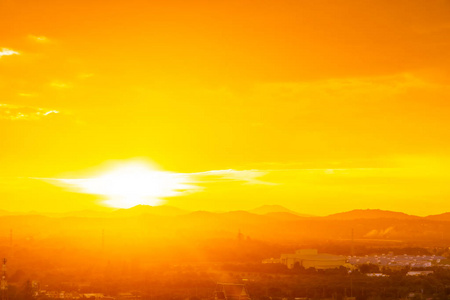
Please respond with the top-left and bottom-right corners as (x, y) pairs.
(0, 0), (450, 215)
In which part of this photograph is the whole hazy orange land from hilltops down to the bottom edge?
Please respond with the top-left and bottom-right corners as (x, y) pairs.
(0, 212), (450, 300)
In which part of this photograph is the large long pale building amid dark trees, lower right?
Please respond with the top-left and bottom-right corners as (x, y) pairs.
(263, 249), (347, 269)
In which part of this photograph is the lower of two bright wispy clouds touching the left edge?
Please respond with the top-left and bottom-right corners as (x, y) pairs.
(0, 103), (60, 121)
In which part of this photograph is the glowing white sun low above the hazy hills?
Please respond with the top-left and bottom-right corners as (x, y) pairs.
(56, 162), (193, 208)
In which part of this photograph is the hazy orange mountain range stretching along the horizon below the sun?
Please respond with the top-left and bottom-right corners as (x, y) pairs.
(0, 205), (450, 249)
